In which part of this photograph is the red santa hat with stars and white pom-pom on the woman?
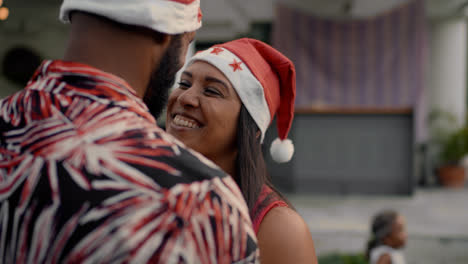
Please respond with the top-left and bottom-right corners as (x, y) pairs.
(188, 38), (296, 163)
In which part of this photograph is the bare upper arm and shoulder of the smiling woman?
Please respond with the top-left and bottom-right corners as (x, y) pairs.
(257, 207), (317, 264)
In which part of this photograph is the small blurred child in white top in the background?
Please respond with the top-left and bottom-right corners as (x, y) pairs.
(366, 210), (407, 264)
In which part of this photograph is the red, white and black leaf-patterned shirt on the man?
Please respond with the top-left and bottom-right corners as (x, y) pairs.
(0, 61), (258, 263)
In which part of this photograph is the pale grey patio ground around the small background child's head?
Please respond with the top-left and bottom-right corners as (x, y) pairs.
(288, 188), (468, 264)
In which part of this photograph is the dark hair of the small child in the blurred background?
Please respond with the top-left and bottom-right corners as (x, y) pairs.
(366, 210), (398, 260)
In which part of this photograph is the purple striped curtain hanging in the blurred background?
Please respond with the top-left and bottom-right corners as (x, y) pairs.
(273, 0), (428, 109)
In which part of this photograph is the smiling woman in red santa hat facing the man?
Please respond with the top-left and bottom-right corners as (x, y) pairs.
(166, 39), (317, 263)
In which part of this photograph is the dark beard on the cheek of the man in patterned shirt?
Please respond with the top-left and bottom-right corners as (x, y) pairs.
(143, 35), (182, 119)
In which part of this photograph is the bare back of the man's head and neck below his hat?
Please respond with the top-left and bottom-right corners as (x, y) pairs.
(64, 13), (165, 98)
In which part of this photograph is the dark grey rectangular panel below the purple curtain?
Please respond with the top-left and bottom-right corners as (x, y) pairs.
(264, 113), (414, 195)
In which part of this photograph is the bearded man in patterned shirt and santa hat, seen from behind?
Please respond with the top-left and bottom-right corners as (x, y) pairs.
(0, 0), (258, 263)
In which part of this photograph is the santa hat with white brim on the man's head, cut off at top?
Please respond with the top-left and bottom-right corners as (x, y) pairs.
(60, 0), (202, 34)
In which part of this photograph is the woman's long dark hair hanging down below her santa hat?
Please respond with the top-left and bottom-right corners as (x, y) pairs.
(235, 105), (293, 219)
